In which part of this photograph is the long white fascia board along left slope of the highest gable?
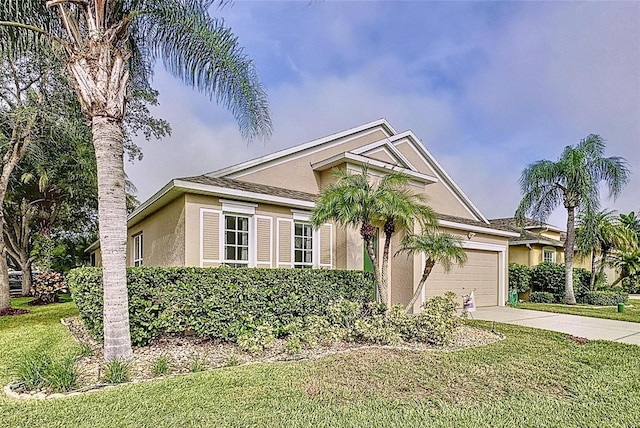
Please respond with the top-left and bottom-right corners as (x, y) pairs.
(204, 119), (397, 178)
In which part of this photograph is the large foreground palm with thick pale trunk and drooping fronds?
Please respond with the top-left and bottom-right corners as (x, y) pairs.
(0, 0), (271, 360)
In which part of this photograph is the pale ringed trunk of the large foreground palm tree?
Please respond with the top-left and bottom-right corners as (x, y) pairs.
(91, 116), (132, 361)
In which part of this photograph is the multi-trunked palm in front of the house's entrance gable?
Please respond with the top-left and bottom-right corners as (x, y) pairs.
(311, 165), (435, 304)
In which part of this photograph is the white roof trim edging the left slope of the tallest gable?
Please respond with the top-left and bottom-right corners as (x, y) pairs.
(204, 119), (397, 178)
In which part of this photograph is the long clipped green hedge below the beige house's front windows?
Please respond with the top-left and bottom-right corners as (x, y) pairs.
(67, 267), (373, 345)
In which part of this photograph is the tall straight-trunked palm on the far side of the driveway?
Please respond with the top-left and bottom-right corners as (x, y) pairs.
(516, 134), (629, 305)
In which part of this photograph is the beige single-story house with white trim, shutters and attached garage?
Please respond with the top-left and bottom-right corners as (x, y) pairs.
(89, 119), (519, 310)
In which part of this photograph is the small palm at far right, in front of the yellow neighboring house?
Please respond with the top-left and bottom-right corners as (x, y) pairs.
(576, 210), (637, 290)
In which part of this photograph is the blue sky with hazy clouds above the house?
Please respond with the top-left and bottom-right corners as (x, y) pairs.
(126, 0), (640, 227)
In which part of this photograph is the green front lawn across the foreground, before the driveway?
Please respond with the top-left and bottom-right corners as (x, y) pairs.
(0, 303), (640, 428)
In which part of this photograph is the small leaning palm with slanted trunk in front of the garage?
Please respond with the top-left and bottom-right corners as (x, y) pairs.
(398, 229), (467, 312)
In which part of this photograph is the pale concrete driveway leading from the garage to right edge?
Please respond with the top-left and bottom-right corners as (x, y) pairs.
(471, 306), (640, 345)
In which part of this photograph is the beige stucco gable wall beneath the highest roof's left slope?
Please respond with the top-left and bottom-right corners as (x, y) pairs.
(229, 130), (387, 194)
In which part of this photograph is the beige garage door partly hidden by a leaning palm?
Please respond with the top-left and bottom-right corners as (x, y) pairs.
(425, 249), (499, 306)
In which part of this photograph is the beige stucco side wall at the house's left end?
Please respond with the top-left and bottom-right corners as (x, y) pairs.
(127, 196), (185, 266)
